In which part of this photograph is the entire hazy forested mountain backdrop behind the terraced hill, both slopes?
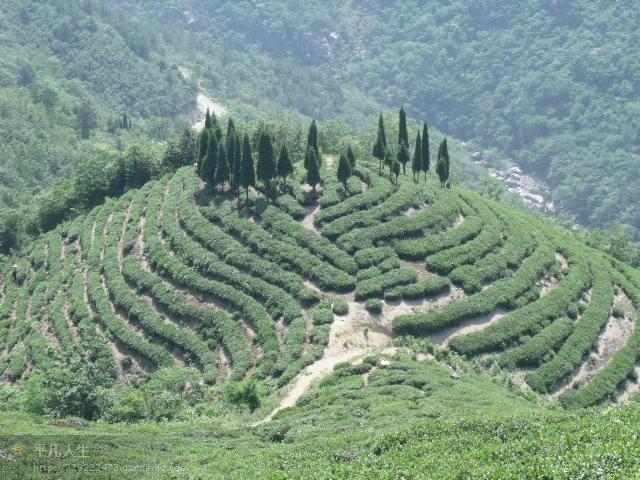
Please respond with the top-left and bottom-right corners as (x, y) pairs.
(0, 0), (640, 248)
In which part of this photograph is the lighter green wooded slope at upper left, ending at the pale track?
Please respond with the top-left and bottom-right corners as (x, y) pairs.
(0, 0), (195, 210)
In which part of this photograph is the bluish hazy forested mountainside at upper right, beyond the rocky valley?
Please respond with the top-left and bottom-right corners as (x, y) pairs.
(110, 0), (640, 233)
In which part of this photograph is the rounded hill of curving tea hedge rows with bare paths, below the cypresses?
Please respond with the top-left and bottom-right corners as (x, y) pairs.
(0, 156), (640, 413)
